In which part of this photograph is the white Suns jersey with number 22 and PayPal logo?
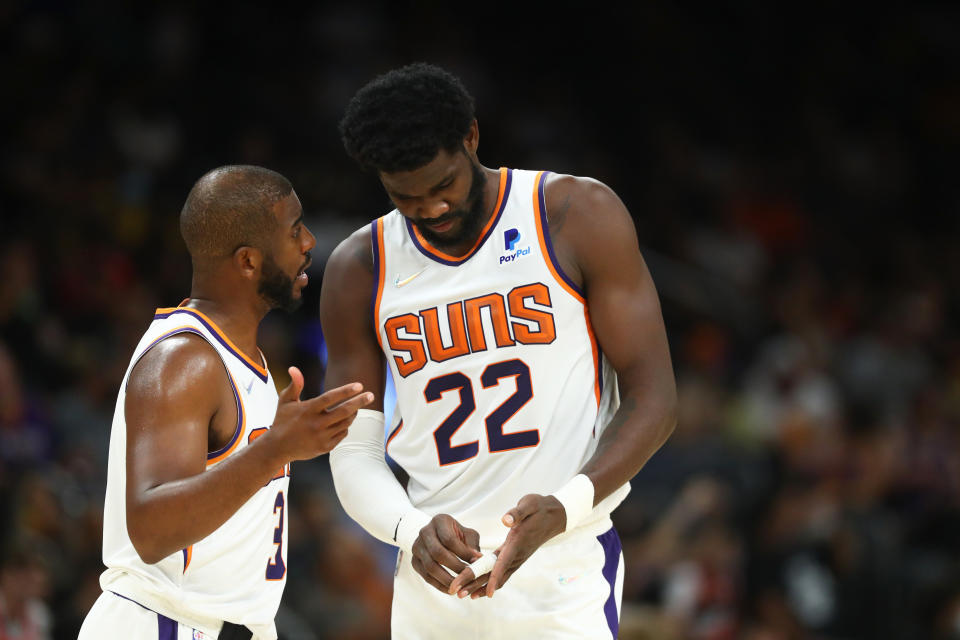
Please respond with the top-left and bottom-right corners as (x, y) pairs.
(371, 169), (629, 548)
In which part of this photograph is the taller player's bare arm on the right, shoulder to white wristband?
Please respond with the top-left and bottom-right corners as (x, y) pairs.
(545, 176), (676, 504)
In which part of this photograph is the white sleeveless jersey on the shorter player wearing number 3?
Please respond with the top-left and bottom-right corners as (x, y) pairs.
(100, 307), (290, 640)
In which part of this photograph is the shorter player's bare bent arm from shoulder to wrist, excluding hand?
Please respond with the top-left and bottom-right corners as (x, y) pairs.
(125, 335), (286, 563)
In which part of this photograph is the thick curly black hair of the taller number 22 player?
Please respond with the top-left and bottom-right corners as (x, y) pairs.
(340, 62), (475, 173)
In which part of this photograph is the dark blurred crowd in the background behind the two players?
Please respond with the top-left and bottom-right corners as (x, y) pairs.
(0, 2), (960, 640)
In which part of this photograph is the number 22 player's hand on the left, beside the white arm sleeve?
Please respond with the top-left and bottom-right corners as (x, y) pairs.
(410, 513), (481, 593)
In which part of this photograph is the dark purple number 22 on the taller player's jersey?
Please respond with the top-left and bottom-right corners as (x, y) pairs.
(423, 360), (540, 466)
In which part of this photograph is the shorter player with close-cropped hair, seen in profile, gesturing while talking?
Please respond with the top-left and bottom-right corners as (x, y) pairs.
(80, 166), (373, 640)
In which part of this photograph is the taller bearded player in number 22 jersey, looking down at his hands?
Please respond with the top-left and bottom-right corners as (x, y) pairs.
(320, 64), (676, 639)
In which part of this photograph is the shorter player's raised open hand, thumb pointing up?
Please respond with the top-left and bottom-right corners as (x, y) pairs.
(270, 367), (373, 461)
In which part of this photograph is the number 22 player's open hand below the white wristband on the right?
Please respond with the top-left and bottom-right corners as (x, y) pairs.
(449, 493), (567, 598)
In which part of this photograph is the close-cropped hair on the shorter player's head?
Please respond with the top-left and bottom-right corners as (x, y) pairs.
(180, 165), (293, 267)
